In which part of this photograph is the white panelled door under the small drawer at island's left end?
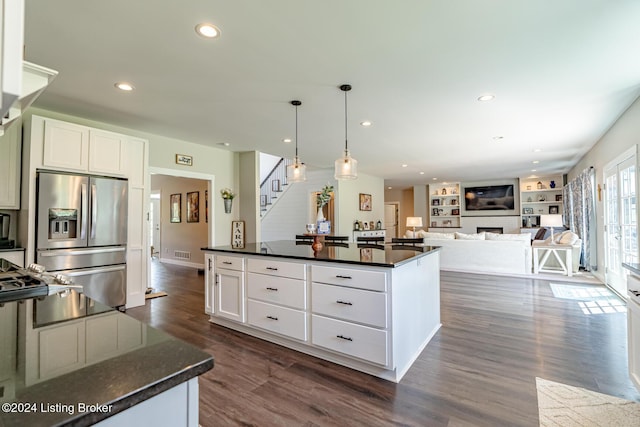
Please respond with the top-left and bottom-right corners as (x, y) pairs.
(215, 268), (244, 322)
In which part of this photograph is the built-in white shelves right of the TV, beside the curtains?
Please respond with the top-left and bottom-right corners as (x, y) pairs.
(520, 175), (562, 228)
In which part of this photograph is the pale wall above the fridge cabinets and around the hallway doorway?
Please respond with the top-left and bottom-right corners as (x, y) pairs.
(25, 108), (242, 245)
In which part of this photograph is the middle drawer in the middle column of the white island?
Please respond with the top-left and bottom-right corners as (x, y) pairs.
(247, 273), (307, 310)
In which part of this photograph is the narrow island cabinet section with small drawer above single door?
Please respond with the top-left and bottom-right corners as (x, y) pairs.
(214, 256), (245, 322)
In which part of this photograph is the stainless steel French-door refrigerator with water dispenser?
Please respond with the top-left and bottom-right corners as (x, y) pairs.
(36, 171), (128, 307)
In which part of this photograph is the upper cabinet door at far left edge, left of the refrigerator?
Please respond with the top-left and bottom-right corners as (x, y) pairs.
(0, 120), (22, 209)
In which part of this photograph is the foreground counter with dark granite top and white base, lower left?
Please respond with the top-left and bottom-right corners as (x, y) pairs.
(0, 288), (213, 427)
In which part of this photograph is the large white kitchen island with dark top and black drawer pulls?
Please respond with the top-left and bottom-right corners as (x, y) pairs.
(203, 241), (441, 382)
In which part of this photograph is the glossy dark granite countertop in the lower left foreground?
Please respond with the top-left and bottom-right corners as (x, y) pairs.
(0, 291), (213, 427)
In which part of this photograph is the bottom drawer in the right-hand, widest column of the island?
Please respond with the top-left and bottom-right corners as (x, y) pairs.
(311, 315), (389, 366)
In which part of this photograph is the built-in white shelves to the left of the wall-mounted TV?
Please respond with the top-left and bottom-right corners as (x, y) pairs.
(425, 182), (460, 228)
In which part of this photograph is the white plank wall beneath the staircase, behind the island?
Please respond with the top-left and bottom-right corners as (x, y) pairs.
(261, 169), (337, 242)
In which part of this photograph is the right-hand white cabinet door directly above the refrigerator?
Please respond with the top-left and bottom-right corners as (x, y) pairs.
(89, 129), (127, 176)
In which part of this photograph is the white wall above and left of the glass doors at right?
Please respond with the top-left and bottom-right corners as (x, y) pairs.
(567, 93), (640, 281)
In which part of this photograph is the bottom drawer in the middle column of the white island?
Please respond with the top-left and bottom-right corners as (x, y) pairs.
(248, 299), (307, 341)
